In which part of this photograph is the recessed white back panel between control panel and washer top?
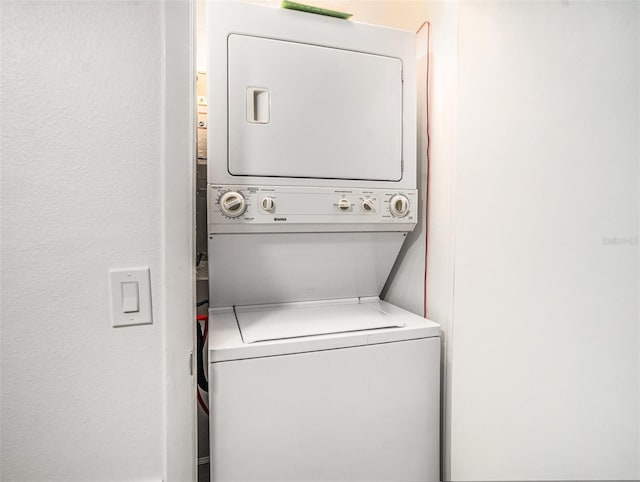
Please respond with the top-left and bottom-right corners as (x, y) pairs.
(209, 232), (406, 307)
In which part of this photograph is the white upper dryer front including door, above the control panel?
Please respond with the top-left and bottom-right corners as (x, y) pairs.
(207, 2), (416, 190)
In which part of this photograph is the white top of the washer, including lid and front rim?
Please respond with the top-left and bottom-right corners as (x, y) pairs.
(209, 297), (440, 363)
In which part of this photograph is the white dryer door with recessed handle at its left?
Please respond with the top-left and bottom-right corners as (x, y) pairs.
(228, 34), (402, 181)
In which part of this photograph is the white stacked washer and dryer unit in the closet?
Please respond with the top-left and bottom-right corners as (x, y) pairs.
(207, 2), (440, 482)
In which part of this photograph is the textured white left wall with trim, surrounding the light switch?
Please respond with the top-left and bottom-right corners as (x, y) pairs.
(0, 1), (193, 481)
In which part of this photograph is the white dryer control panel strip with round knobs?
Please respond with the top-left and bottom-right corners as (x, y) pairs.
(208, 185), (418, 234)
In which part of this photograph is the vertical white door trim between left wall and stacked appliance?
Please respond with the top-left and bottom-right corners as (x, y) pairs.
(160, 0), (198, 482)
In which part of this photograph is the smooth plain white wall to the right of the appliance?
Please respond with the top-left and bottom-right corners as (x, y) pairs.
(448, 1), (640, 480)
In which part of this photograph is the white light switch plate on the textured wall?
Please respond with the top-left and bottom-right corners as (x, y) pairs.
(109, 268), (153, 326)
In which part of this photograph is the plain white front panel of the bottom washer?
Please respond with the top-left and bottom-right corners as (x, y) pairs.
(210, 337), (440, 482)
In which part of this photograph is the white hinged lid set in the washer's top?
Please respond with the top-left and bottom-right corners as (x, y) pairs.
(236, 300), (405, 343)
